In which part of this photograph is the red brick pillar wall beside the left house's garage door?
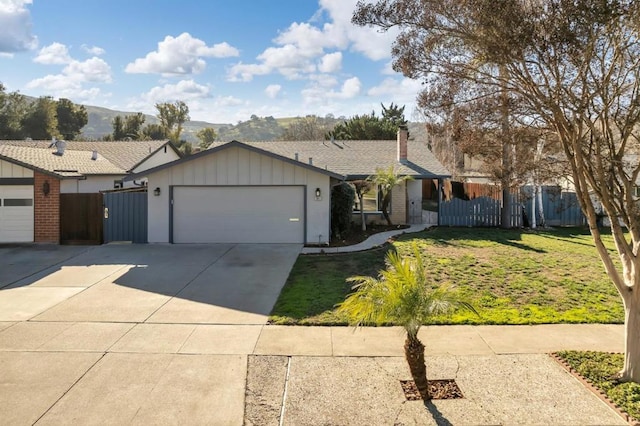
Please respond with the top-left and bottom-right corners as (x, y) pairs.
(33, 172), (60, 244)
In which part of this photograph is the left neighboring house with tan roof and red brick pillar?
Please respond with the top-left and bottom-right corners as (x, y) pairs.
(0, 141), (180, 243)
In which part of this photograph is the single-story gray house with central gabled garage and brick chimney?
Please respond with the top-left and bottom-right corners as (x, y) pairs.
(127, 131), (450, 244)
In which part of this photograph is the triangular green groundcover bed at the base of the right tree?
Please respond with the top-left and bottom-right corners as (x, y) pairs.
(558, 351), (640, 419)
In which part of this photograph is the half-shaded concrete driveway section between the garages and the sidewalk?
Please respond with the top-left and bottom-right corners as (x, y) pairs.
(0, 244), (301, 324)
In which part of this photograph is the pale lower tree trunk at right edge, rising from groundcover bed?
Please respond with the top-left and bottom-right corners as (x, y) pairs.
(620, 288), (640, 383)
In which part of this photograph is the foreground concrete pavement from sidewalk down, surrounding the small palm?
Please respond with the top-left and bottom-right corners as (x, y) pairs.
(0, 321), (625, 425)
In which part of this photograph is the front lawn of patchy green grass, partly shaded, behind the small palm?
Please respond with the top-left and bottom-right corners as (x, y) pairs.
(270, 228), (624, 325)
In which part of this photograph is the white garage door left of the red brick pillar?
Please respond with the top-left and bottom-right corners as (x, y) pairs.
(0, 185), (33, 243)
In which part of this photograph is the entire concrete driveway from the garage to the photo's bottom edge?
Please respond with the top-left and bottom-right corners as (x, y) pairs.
(0, 244), (302, 425)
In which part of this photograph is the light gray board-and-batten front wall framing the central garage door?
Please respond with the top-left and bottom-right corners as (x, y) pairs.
(148, 147), (331, 243)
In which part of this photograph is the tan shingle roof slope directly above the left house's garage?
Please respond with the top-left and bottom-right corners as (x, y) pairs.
(0, 144), (127, 178)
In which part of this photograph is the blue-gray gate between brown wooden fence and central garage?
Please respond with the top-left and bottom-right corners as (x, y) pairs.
(103, 192), (148, 243)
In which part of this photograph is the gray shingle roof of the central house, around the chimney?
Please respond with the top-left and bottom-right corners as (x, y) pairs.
(209, 140), (451, 180)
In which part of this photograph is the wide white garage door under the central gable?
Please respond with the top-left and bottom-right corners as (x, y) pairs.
(173, 186), (304, 243)
